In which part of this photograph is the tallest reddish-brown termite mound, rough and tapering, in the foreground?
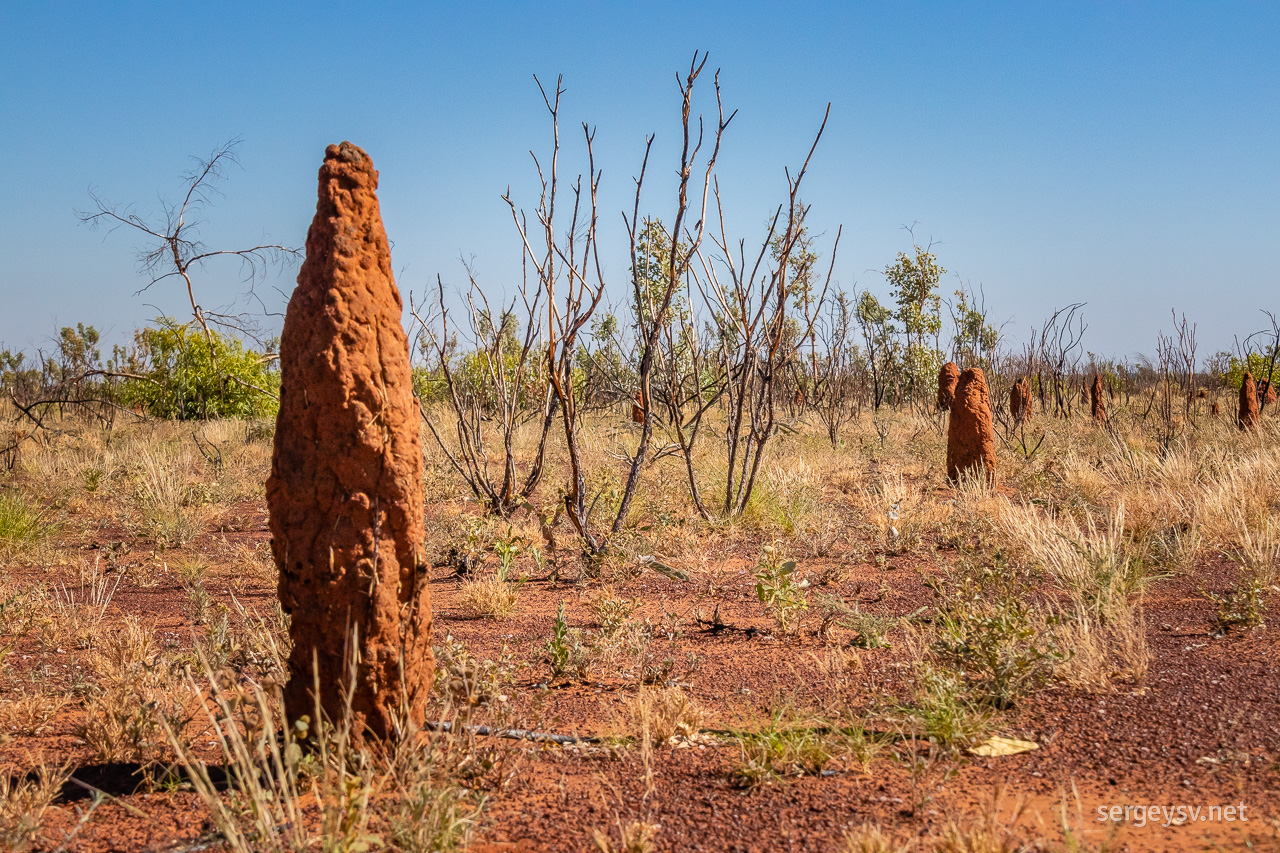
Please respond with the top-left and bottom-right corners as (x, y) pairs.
(266, 142), (434, 738)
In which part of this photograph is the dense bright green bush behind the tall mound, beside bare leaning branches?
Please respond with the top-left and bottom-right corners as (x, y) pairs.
(114, 318), (280, 420)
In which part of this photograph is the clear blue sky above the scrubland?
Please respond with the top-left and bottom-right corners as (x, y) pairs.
(0, 0), (1280, 356)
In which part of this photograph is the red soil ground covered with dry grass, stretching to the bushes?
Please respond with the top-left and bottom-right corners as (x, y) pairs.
(0, 394), (1280, 853)
